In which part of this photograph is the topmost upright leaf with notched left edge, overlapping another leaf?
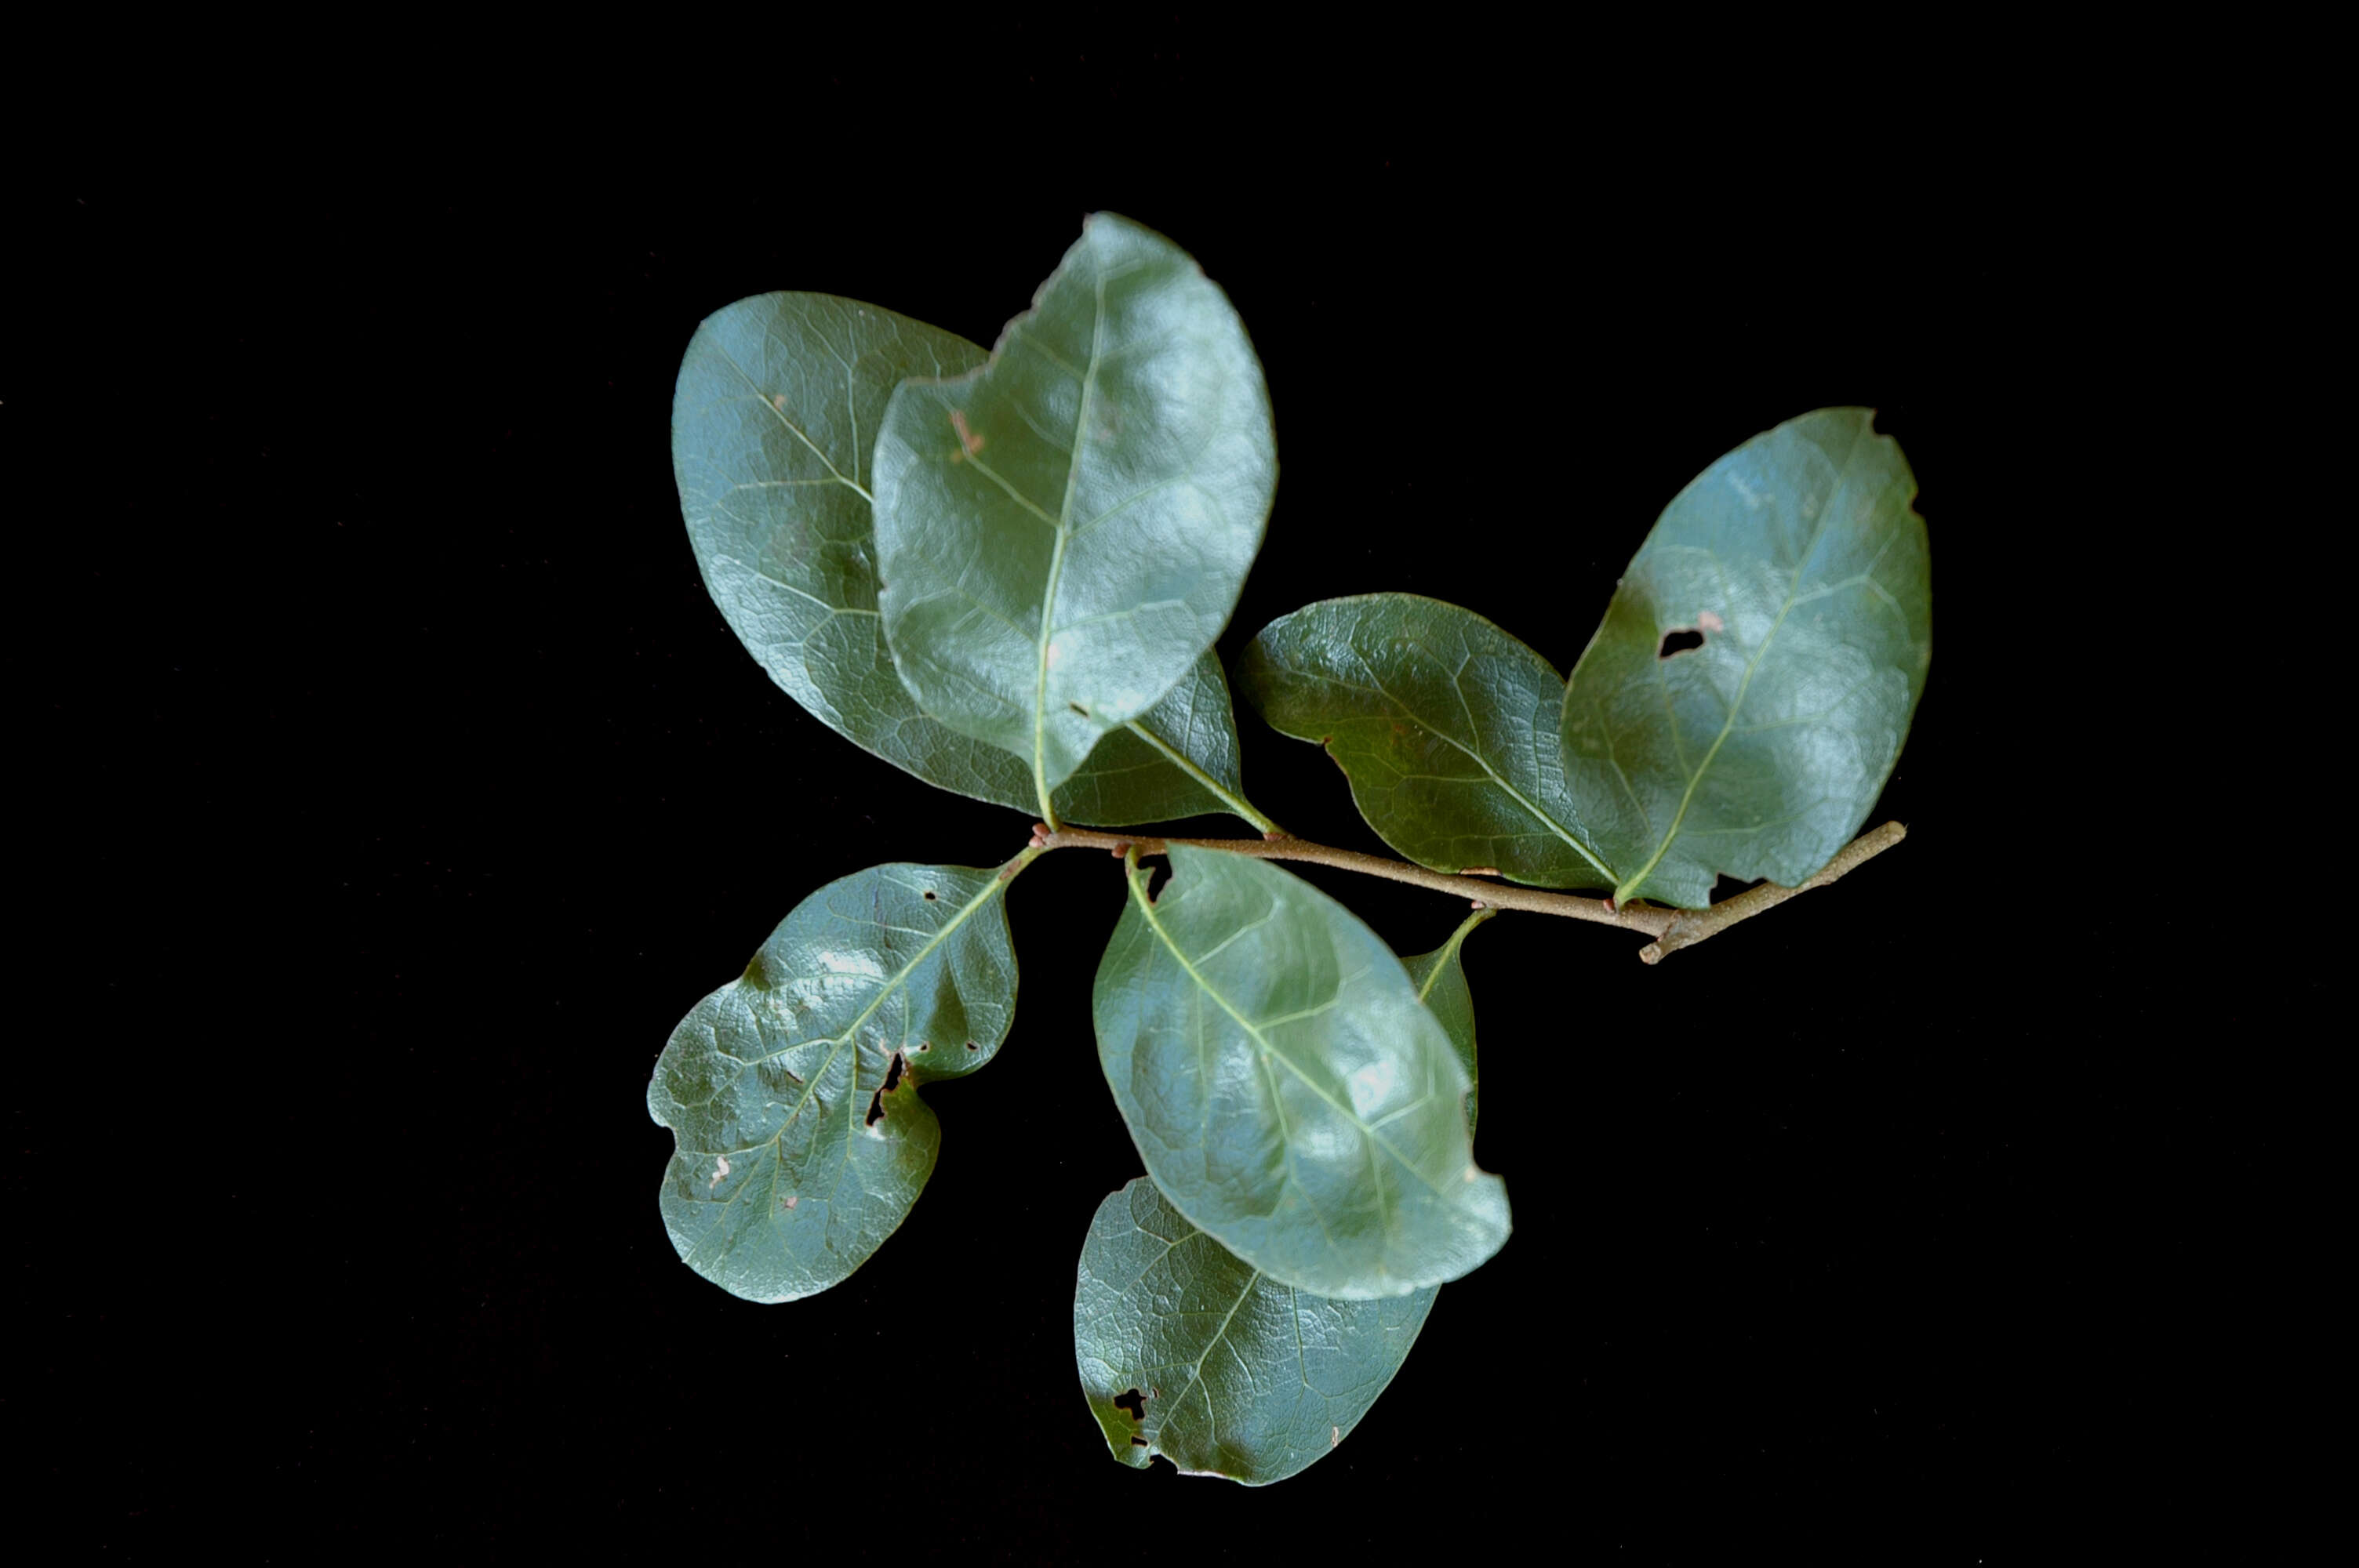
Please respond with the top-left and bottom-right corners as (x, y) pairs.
(875, 215), (1276, 802)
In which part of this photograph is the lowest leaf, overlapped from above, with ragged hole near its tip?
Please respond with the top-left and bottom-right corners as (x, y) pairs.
(1074, 1177), (1439, 1486)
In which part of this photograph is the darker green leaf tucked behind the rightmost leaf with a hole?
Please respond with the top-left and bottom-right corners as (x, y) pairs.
(1236, 594), (1613, 887)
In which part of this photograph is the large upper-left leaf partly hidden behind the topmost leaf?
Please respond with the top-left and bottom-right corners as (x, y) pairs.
(672, 292), (1267, 828)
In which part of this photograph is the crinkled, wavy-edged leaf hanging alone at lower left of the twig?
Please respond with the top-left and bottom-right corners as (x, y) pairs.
(646, 866), (1016, 1301)
